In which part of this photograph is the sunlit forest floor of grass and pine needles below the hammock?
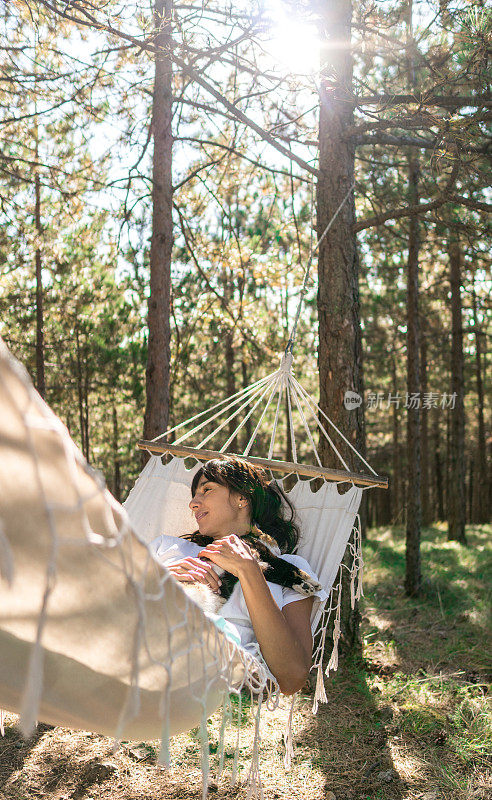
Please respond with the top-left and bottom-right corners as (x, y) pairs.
(0, 525), (492, 800)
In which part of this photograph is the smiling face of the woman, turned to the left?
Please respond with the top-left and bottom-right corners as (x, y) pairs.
(190, 475), (249, 539)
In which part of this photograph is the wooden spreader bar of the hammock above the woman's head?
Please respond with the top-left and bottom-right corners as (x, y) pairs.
(137, 439), (388, 489)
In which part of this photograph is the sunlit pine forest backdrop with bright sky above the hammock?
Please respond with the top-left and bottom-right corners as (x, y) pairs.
(0, 0), (491, 544)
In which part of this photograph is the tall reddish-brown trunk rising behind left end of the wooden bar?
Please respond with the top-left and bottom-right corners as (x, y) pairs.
(144, 0), (173, 439)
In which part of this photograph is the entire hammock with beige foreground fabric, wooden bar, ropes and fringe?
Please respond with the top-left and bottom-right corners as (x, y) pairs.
(0, 340), (385, 791)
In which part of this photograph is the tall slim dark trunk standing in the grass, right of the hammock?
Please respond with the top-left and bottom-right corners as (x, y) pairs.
(405, 0), (422, 597)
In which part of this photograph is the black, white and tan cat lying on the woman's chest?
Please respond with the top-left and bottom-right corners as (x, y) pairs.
(181, 526), (322, 614)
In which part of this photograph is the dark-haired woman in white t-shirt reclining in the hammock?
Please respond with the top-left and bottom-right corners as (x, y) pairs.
(153, 457), (326, 694)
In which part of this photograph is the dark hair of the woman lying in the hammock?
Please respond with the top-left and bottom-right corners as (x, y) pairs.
(191, 456), (299, 553)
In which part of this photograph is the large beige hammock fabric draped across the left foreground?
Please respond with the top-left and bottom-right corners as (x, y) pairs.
(0, 340), (268, 776)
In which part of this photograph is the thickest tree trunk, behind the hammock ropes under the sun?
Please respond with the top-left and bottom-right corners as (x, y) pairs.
(316, 0), (363, 650)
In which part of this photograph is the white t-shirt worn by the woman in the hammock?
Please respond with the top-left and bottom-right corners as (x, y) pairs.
(150, 534), (328, 657)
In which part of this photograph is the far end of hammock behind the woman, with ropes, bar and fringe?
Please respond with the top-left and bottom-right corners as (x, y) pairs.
(128, 351), (385, 711)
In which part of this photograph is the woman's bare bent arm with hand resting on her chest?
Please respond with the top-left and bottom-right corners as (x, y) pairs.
(200, 536), (313, 694)
